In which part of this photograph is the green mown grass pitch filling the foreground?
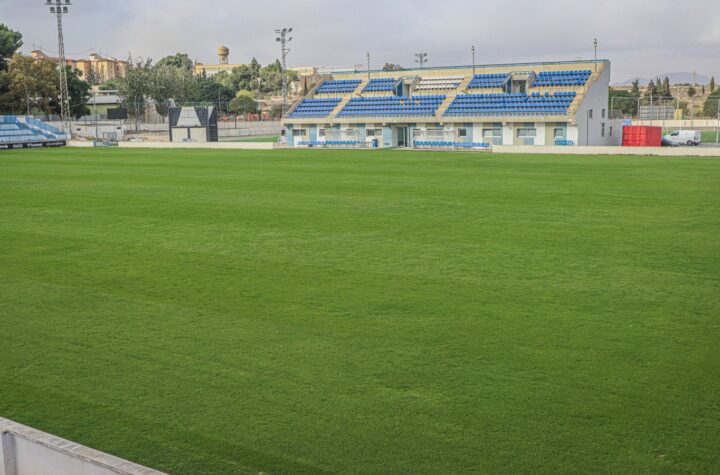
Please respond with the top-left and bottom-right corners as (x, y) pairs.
(0, 149), (720, 474)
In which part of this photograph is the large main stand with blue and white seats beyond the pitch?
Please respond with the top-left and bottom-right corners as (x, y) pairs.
(283, 60), (622, 150)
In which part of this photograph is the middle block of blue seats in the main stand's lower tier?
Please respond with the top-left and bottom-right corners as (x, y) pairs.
(338, 95), (446, 117)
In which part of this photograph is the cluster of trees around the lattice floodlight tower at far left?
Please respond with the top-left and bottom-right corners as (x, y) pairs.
(0, 24), (90, 118)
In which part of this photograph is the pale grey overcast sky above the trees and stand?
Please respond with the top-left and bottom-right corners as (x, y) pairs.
(0, 0), (720, 81)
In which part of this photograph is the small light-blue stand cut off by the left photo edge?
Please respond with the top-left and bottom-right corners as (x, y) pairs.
(0, 115), (67, 149)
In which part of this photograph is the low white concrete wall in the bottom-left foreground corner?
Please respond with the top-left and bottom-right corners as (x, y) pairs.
(0, 417), (164, 475)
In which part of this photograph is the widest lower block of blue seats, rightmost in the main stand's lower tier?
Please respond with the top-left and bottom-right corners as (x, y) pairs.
(445, 92), (576, 117)
